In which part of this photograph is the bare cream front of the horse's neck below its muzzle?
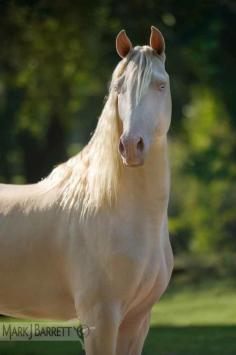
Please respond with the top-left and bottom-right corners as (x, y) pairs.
(121, 137), (169, 211)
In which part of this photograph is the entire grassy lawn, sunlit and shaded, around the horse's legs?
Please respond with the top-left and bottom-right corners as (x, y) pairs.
(0, 280), (236, 355)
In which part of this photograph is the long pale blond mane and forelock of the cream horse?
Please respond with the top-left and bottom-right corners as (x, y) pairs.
(42, 46), (156, 215)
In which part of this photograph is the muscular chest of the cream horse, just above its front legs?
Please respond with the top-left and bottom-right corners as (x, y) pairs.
(106, 222), (171, 314)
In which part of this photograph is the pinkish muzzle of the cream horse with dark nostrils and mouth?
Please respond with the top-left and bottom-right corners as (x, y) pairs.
(119, 134), (144, 166)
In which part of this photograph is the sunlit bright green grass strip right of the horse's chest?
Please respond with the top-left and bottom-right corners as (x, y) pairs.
(152, 281), (236, 326)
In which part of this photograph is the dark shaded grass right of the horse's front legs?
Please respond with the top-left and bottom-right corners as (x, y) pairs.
(143, 325), (236, 355)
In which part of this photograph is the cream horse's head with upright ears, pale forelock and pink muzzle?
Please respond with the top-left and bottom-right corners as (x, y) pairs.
(113, 27), (171, 166)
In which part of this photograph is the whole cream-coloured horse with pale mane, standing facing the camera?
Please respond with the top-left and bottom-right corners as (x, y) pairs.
(0, 27), (173, 355)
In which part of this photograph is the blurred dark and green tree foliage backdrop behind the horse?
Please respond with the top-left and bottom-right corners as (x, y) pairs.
(0, 0), (236, 253)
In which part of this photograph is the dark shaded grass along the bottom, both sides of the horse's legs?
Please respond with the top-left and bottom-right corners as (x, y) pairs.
(0, 326), (236, 355)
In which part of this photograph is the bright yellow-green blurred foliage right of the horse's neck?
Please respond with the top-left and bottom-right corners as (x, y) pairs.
(170, 86), (236, 252)
